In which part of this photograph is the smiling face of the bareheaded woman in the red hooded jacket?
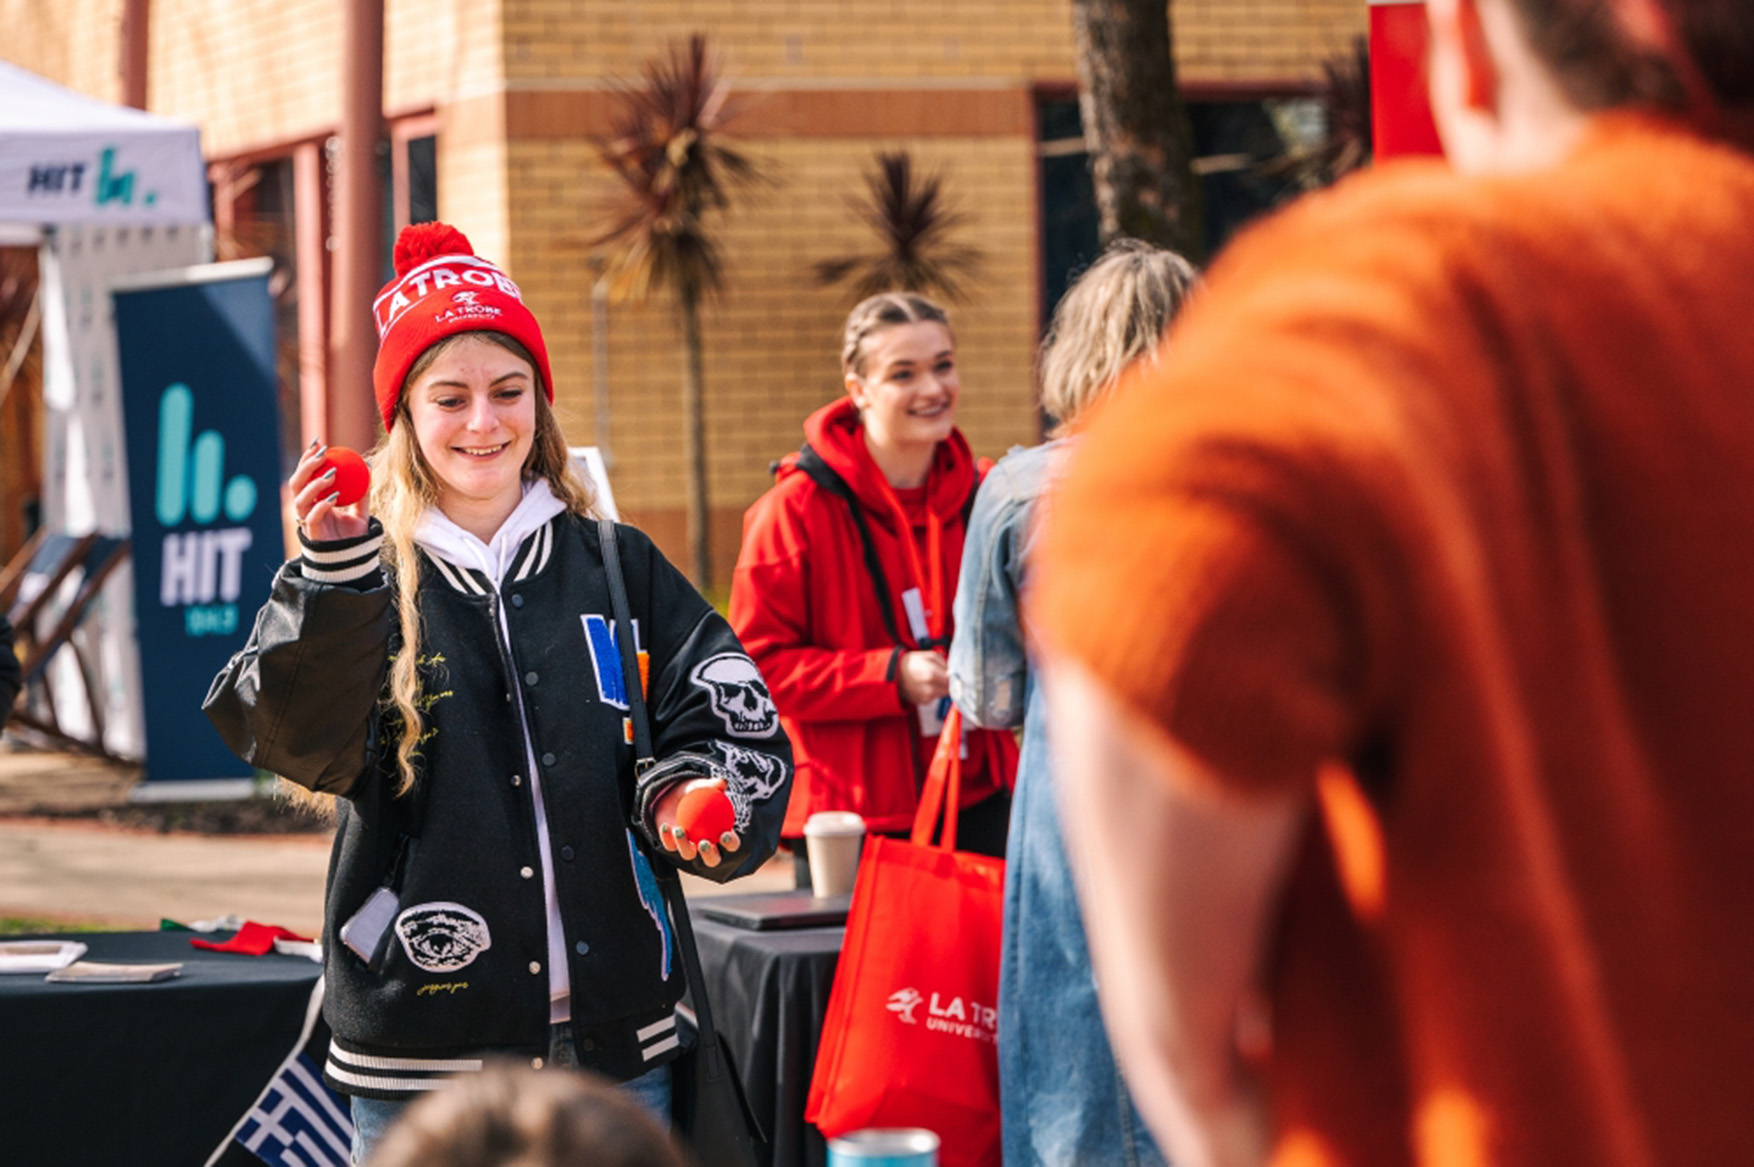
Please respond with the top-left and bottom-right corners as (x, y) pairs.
(847, 321), (961, 453)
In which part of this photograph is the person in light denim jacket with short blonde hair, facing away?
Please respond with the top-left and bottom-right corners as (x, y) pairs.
(949, 240), (1194, 1167)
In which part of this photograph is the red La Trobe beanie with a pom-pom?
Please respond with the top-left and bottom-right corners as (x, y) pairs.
(372, 223), (554, 433)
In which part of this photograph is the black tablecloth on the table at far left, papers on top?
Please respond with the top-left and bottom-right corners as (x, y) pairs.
(0, 932), (321, 1167)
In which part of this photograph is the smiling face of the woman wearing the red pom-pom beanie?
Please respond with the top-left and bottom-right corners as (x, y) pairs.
(405, 335), (537, 537)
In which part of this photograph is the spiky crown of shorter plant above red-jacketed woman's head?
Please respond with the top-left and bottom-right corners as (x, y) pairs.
(812, 151), (984, 302)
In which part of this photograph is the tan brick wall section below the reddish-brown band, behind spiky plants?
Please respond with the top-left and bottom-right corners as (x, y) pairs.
(507, 137), (1037, 512)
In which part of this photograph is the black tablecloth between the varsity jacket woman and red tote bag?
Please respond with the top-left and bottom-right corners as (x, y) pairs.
(693, 911), (845, 1167)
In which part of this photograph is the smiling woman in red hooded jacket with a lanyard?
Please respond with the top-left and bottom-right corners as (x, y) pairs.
(731, 293), (1017, 883)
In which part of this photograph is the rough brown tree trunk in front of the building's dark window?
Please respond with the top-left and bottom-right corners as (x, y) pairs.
(1072, 0), (1205, 261)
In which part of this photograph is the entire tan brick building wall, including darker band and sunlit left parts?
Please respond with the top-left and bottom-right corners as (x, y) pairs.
(0, 0), (1366, 577)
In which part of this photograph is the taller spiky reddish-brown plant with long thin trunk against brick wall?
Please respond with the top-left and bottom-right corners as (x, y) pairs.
(588, 33), (763, 590)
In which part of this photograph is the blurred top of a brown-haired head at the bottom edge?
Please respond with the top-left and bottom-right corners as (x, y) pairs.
(367, 1063), (686, 1167)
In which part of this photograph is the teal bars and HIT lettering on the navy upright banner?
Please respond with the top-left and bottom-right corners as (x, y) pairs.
(154, 383), (258, 635)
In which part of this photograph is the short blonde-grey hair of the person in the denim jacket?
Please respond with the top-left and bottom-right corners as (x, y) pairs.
(1038, 239), (1196, 433)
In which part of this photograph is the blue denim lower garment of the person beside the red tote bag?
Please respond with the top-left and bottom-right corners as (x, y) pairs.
(998, 708), (1165, 1167)
